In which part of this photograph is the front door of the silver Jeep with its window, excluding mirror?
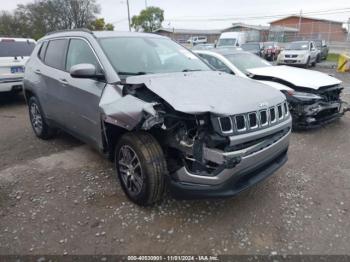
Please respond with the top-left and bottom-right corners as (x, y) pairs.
(61, 38), (106, 147)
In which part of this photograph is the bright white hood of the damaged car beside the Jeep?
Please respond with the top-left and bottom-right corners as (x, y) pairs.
(248, 66), (341, 90)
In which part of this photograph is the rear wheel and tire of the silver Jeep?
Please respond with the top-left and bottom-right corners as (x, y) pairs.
(28, 96), (56, 140)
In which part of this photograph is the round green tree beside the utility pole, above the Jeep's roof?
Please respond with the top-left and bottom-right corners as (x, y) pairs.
(131, 6), (164, 32)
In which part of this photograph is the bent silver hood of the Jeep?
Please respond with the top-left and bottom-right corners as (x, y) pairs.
(126, 71), (285, 115)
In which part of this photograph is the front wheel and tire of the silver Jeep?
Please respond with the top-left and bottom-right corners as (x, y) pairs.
(115, 132), (168, 206)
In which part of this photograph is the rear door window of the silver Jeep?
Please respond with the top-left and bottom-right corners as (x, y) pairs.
(45, 39), (67, 70)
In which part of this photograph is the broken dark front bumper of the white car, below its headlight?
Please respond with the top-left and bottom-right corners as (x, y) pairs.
(291, 101), (350, 129)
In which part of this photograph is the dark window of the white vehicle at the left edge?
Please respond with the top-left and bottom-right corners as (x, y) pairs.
(0, 40), (35, 57)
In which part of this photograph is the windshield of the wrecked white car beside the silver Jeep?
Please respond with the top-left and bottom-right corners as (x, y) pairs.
(225, 53), (271, 74)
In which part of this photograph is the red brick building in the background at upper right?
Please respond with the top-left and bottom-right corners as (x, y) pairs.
(270, 15), (347, 42)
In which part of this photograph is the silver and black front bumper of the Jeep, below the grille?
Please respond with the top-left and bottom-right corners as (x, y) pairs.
(170, 118), (291, 198)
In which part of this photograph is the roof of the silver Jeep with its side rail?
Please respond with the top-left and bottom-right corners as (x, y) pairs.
(40, 29), (167, 40)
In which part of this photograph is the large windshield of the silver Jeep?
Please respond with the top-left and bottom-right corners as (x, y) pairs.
(100, 37), (211, 77)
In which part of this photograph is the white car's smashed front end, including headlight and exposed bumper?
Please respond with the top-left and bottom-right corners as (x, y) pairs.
(285, 85), (349, 129)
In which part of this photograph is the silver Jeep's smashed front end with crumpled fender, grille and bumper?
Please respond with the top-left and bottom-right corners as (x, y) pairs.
(100, 75), (291, 197)
